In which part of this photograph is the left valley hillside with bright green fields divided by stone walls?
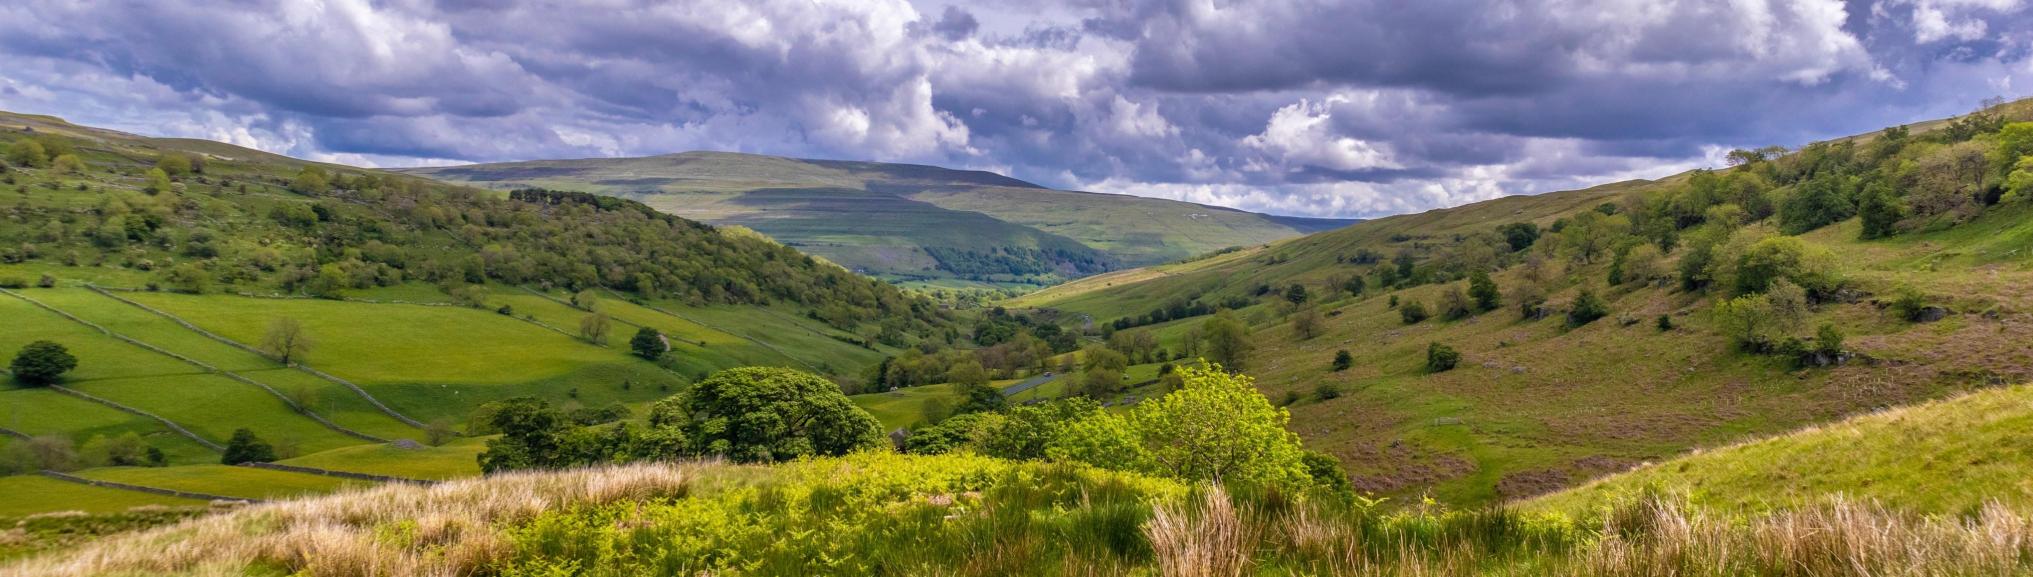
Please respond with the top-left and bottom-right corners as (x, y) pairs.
(0, 114), (956, 518)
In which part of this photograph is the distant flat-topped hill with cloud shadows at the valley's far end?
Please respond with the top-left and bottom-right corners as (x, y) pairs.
(405, 152), (1348, 284)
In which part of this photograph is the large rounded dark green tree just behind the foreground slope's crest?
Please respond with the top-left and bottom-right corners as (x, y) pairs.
(685, 368), (886, 463)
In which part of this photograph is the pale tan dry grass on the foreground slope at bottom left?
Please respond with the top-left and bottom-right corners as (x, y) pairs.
(0, 463), (716, 577)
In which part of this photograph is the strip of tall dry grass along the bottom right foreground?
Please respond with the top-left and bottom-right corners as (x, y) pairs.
(1147, 492), (2033, 577)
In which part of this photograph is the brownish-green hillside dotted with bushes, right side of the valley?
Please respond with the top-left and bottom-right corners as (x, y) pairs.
(1024, 102), (2033, 504)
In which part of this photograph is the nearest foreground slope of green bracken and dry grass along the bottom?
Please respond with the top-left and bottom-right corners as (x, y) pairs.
(15, 453), (2033, 577)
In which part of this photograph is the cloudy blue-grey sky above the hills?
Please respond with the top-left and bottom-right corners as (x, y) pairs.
(0, 0), (2033, 217)
